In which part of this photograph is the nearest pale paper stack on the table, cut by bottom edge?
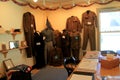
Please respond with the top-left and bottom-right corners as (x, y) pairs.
(70, 74), (93, 80)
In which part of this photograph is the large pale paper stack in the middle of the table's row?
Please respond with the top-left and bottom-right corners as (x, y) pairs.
(77, 58), (98, 73)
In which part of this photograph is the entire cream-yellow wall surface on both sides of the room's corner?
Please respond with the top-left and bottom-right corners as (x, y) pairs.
(0, 1), (119, 71)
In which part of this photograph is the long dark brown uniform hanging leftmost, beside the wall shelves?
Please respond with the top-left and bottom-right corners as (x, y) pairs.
(23, 12), (36, 57)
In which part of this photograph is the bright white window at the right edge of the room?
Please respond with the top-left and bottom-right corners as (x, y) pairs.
(99, 7), (120, 52)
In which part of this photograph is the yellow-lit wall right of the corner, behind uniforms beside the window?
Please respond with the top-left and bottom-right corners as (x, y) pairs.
(47, 2), (119, 50)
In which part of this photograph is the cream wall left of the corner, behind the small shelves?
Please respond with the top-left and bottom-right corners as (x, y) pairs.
(0, 1), (46, 71)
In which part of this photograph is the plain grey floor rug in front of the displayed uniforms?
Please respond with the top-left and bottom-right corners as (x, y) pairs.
(32, 67), (68, 80)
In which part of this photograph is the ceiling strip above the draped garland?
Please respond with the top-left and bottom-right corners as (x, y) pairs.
(1, 0), (120, 10)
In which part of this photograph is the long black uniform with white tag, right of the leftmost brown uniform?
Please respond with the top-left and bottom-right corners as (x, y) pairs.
(34, 31), (45, 69)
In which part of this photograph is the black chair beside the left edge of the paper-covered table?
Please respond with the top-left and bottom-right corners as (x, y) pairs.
(64, 57), (77, 76)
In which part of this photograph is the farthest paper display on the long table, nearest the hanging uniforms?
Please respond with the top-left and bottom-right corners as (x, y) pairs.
(84, 51), (100, 59)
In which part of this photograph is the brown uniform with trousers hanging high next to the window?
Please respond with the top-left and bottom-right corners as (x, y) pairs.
(82, 10), (97, 50)
